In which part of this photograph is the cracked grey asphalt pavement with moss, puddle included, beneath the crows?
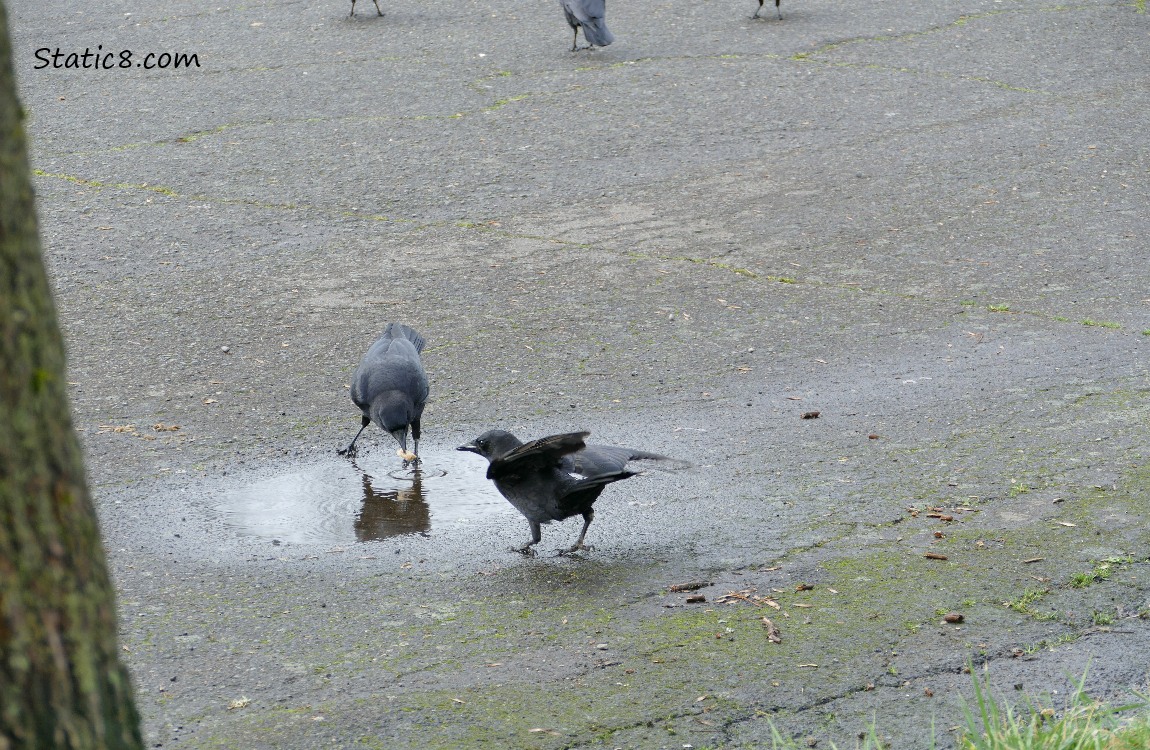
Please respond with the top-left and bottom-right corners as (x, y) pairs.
(7, 0), (1150, 749)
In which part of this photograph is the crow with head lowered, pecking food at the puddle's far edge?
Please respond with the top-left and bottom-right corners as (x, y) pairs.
(339, 323), (428, 467)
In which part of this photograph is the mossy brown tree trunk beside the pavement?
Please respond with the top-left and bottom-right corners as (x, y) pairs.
(0, 2), (143, 750)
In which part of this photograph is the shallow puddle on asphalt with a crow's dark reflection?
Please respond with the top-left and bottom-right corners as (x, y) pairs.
(215, 454), (509, 544)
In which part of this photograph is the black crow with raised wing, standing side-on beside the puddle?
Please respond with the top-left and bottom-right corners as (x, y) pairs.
(455, 430), (674, 557)
